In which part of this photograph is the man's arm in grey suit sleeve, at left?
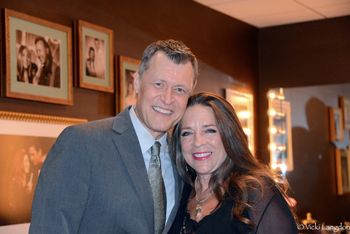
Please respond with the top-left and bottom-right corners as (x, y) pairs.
(29, 127), (90, 234)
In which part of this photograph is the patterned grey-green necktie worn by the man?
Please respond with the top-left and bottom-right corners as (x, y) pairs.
(148, 141), (166, 234)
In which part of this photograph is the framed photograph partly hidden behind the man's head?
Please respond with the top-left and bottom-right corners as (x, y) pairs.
(116, 56), (140, 112)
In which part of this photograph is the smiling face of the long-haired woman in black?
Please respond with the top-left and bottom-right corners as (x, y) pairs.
(180, 104), (227, 175)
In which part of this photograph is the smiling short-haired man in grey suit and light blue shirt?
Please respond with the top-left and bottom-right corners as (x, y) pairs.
(30, 40), (198, 234)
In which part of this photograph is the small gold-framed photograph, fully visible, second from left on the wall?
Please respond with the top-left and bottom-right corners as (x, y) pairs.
(78, 20), (114, 93)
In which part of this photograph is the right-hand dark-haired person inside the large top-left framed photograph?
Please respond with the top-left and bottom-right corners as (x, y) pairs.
(33, 36), (60, 88)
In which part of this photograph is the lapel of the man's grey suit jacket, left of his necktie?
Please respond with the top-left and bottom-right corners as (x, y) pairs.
(112, 109), (153, 230)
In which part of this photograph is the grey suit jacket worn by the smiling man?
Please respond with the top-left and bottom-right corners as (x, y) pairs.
(30, 108), (182, 234)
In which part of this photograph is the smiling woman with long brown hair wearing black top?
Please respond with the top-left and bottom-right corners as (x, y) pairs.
(170, 93), (297, 234)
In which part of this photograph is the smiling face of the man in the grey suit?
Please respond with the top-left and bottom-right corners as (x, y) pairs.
(135, 52), (194, 139)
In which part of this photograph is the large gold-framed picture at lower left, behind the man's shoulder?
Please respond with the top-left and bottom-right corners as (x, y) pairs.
(0, 111), (86, 226)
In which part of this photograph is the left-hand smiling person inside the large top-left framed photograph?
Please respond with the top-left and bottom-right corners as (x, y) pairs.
(17, 45), (38, 83)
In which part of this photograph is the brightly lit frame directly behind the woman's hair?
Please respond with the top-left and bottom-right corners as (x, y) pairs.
(225, 89), (255, 155)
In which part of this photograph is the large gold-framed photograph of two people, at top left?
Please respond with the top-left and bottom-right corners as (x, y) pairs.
(4, 9), (73, 105)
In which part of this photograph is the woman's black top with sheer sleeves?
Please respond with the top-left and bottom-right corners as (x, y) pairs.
(168, 185), (297, 234)
